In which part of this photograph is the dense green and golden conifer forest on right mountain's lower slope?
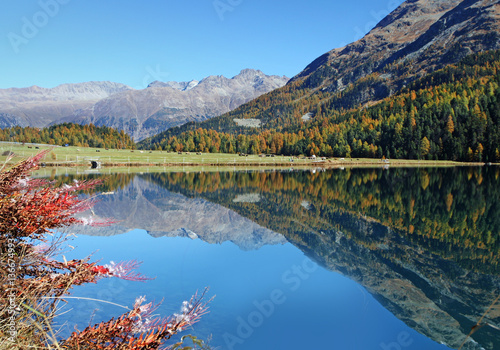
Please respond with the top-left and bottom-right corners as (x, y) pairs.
(139, 50), (500, 162)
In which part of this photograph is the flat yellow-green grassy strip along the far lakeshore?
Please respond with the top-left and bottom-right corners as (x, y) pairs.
(0, 143), (492, 169)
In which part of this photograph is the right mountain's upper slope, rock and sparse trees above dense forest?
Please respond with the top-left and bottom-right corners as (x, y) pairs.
(152, 0), (500, 139)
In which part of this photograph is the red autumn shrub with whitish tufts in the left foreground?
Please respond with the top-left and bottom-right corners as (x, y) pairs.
(0, 151), (211, 350)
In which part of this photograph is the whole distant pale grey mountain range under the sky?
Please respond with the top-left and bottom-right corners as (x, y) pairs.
(0, 69), (288, 141)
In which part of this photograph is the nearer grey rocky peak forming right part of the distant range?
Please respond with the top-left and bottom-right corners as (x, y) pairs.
(69, 69), (288, 141)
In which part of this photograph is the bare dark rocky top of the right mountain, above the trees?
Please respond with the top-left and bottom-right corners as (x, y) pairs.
(290, 0), (500, 103)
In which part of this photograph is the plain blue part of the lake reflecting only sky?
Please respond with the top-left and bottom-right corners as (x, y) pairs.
(58, 230), (448, 350)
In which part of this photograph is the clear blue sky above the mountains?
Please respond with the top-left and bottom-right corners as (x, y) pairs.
(0, 0), (402, 88)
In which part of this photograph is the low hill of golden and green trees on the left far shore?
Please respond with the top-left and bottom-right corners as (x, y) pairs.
(0, 123), (135, 149)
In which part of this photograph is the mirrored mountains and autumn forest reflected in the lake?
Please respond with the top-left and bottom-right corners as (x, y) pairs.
(52, 168), (500, 349)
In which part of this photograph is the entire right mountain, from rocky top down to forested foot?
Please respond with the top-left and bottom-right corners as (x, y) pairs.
(142, 0), (500, 161)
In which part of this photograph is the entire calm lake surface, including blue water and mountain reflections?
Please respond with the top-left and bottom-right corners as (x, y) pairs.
(44, 167), (500, 350)
